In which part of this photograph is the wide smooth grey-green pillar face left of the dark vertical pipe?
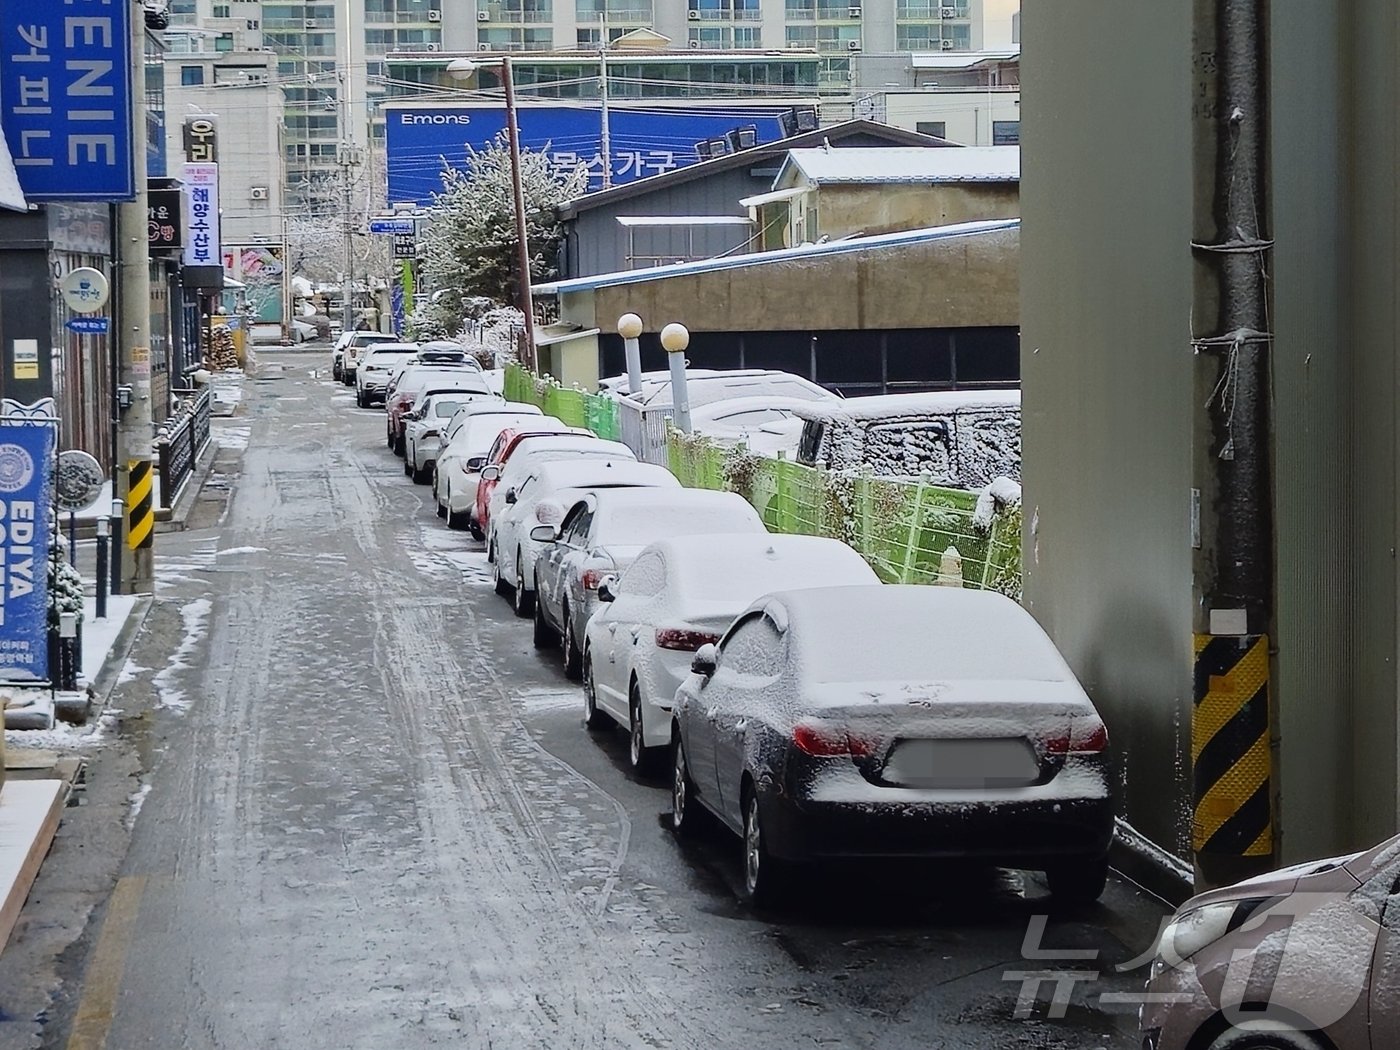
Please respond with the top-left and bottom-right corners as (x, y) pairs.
(1021, 0), (1196, 851)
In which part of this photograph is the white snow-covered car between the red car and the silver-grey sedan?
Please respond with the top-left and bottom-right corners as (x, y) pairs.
(491, 459), (680, 616)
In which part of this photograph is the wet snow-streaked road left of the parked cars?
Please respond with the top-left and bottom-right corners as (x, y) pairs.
(30, 353), (1161, 1050)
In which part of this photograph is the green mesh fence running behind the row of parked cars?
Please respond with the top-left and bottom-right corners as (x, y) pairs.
(505, 365), (1021, 599)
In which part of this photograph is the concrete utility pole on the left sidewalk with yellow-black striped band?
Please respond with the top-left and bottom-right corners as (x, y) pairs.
(112, 0), (155, 594)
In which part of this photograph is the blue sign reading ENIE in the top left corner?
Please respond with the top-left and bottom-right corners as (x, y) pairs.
(0, 0), (135, 200)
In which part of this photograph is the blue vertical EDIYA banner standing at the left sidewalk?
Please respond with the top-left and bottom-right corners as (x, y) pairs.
(0, 420), (57, 682)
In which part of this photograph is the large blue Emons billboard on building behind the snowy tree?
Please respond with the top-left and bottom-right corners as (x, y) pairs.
(385, 99), (792, 207)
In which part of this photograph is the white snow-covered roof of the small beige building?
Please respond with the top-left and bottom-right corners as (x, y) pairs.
(773, 146), (1021, 188)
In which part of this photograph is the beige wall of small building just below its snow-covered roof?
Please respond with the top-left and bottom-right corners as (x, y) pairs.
(806, 182), (1021, 241)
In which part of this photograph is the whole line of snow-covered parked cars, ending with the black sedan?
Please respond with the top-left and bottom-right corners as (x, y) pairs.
(344, 366), (1113, 918)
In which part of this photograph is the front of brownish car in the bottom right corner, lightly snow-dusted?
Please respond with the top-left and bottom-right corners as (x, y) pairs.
(1138, 839), (1400, 1050)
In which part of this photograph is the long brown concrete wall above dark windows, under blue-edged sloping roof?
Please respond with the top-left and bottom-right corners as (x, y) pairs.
(579, 231), (1021, 332)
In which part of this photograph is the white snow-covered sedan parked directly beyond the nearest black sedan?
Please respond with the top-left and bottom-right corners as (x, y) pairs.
(584, 535), (879, 771)
